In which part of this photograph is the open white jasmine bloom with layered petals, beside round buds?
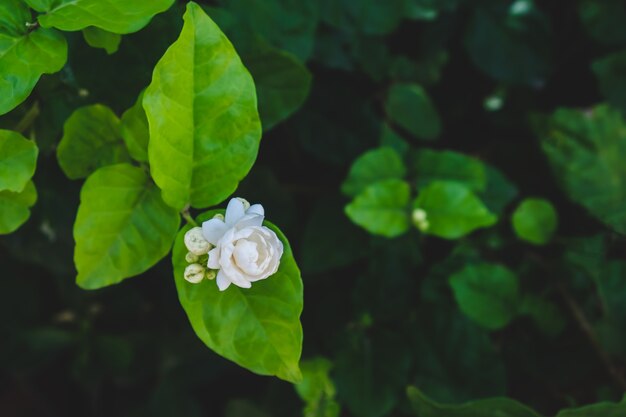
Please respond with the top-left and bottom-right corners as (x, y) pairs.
(202, 198), (283, 291)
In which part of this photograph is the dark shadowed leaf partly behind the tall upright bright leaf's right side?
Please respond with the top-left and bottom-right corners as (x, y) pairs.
(244, 42), (311, 131)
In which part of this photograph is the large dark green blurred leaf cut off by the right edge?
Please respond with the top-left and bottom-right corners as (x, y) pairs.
(539, 105), (626, 233)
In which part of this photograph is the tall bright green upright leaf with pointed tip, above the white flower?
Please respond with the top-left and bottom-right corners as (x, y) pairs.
(143, 3), (261, 209)
